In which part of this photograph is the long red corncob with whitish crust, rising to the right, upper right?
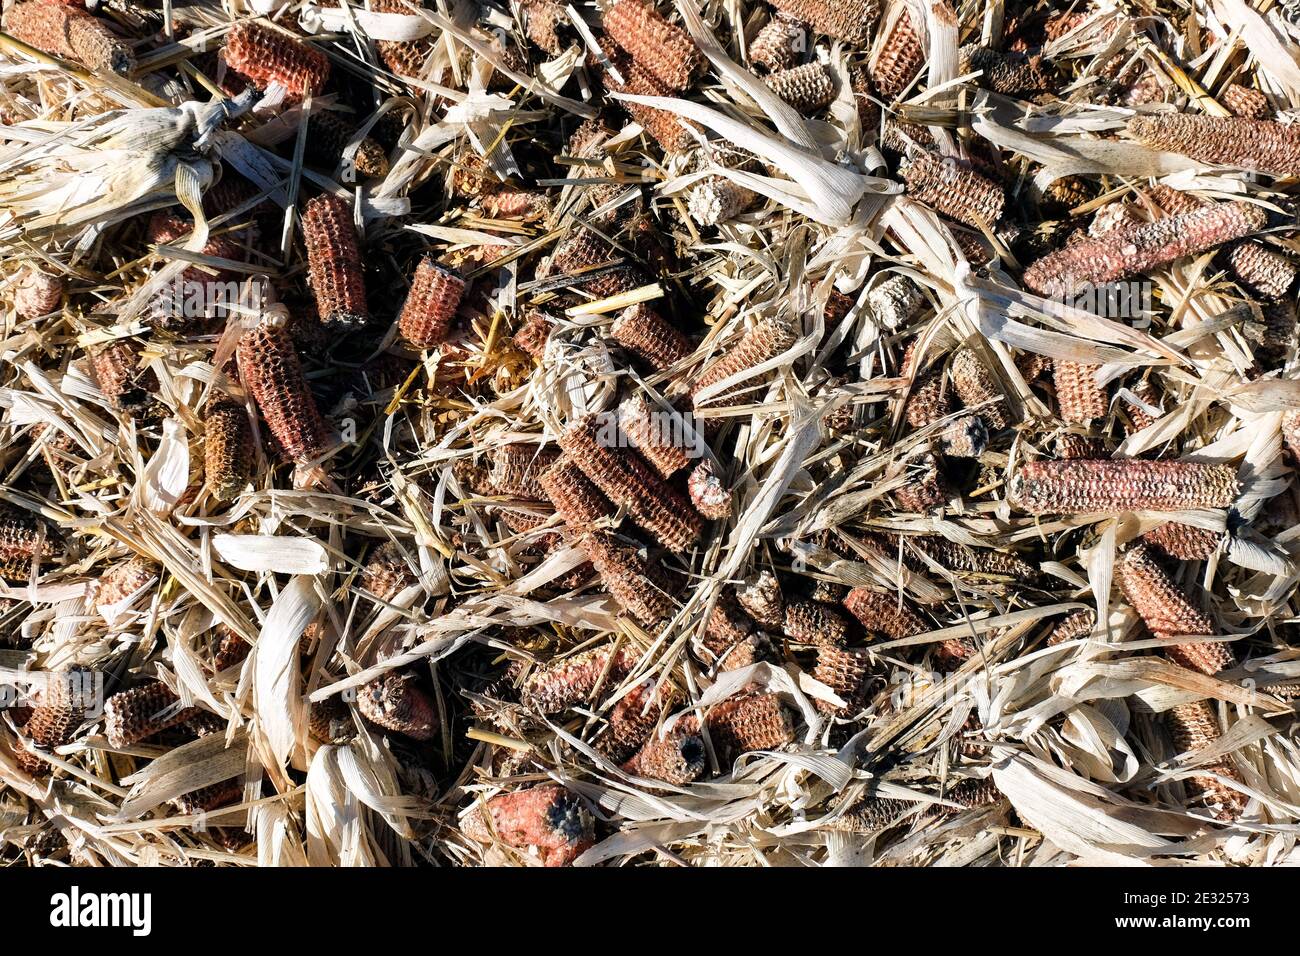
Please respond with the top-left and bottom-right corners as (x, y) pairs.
(1024, 202), (1269, 297)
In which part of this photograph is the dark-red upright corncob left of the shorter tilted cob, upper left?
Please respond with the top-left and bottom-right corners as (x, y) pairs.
(303, 194), (366, 328)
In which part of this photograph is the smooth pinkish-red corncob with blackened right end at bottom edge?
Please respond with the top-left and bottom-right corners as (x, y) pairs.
(462, 783), (595, 866)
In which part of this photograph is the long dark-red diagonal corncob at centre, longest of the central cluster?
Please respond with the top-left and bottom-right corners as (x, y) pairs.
(560, 414), (702, 551)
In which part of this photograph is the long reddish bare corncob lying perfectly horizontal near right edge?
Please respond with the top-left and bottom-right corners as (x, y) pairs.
(1008, 459), (1238, 515)
